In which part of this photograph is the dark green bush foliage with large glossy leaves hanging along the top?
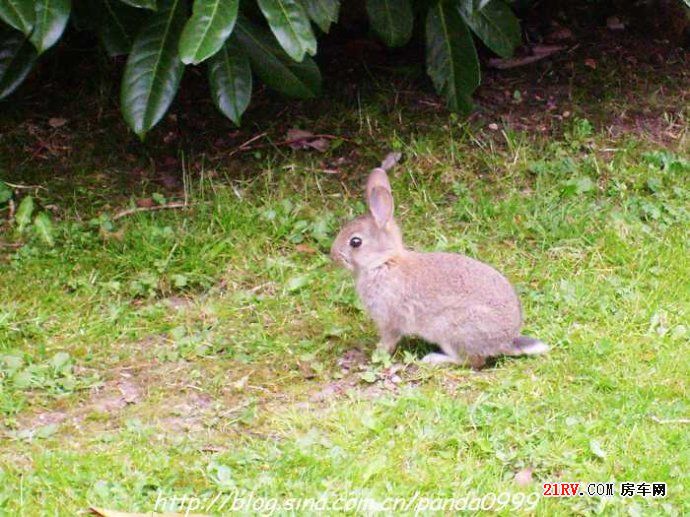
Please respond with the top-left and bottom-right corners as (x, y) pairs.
(0, 0), (690, 138)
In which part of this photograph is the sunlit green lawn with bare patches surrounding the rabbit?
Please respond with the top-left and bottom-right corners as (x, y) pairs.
(0, 95), (690, 515)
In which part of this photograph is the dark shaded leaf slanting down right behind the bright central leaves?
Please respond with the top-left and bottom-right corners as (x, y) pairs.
(235, 19), (321, 99)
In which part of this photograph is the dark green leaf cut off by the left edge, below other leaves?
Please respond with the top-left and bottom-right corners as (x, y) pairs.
(0, 29), (36, 99)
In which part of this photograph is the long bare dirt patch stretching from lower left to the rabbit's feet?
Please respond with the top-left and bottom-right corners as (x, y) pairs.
(8, 338), (494, 444)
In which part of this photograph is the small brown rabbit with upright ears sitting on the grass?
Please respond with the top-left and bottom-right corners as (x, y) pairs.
(330, 155), (549, 369)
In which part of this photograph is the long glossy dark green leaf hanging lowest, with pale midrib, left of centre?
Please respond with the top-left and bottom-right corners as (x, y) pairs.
(120, 0), (186, 138)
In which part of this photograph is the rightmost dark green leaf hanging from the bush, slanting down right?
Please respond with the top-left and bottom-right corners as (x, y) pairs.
(458, 0), (522, 58)
